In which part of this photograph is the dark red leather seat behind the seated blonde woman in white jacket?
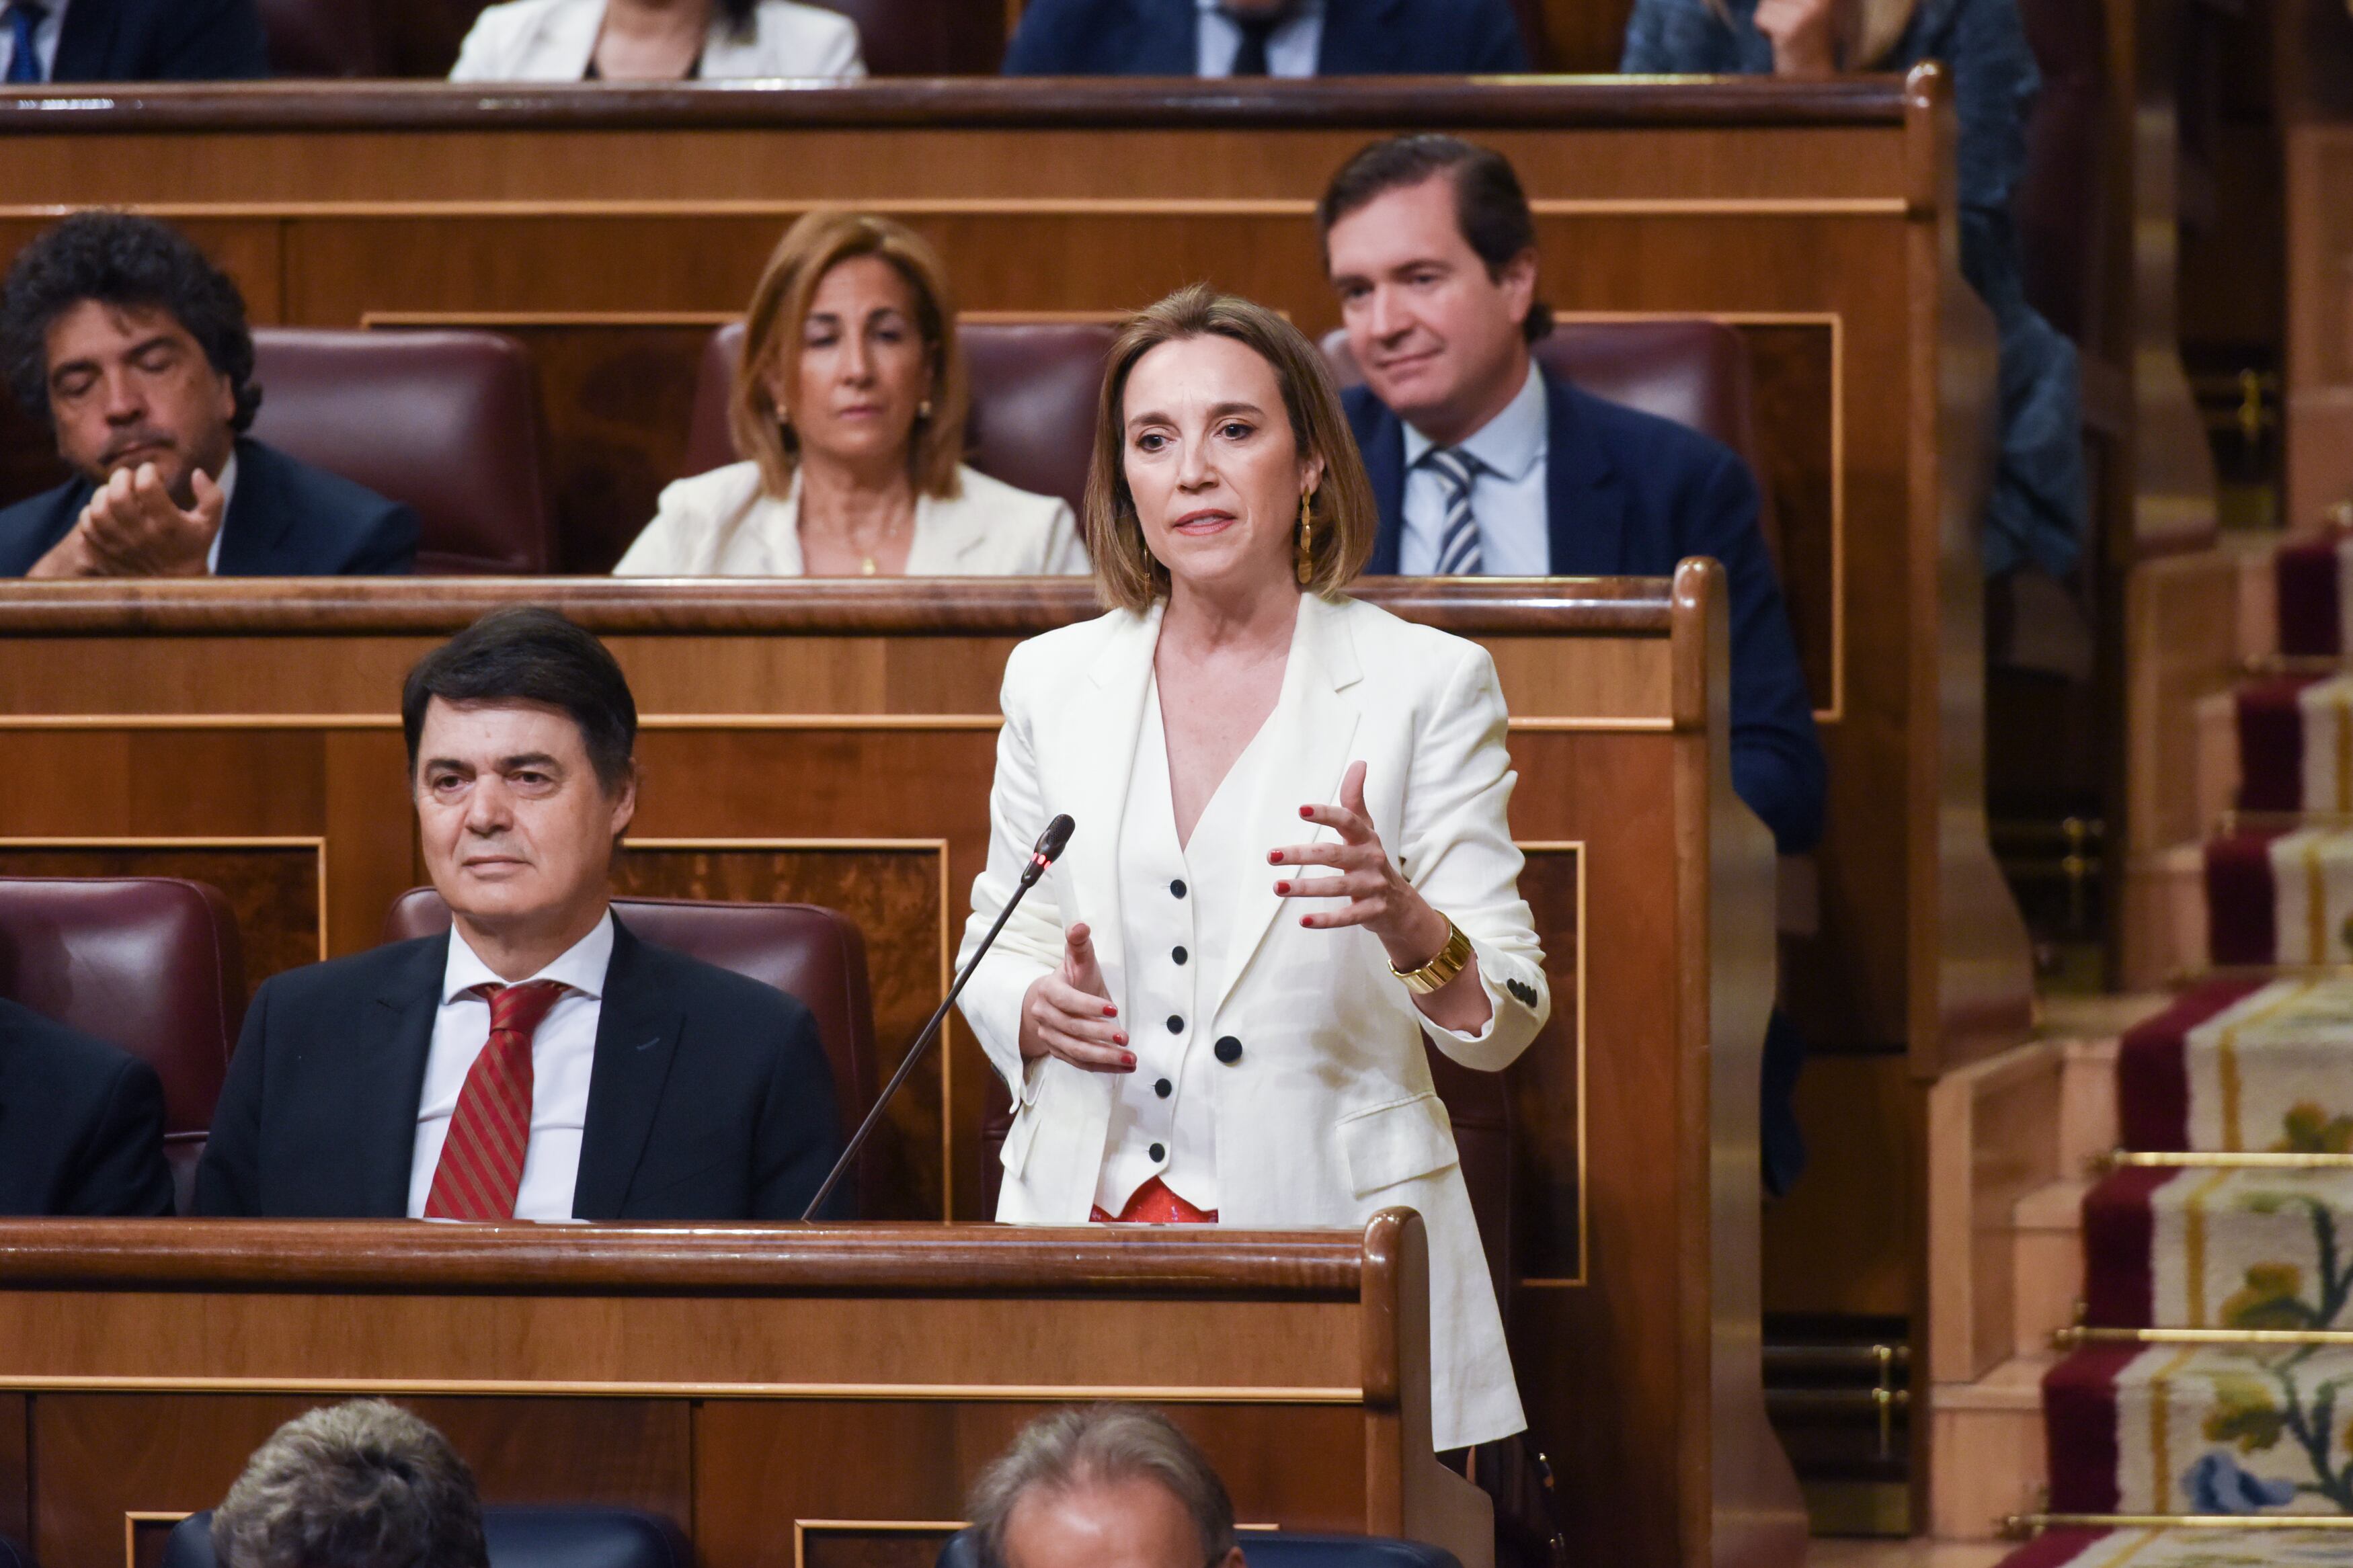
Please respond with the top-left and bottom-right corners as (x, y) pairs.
(687, 322), (1118, 513)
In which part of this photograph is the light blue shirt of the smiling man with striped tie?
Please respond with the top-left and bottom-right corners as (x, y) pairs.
(1398, 364), (1553, 576)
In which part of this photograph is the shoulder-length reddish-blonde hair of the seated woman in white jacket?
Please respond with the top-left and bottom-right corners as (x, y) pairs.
(727, 212), (972, 499)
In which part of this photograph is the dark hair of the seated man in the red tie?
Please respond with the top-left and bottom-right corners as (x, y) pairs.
(400, 604), (638, 794)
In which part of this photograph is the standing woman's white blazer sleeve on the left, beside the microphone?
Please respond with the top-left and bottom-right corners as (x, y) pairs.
(955, 649), (1062, 1102)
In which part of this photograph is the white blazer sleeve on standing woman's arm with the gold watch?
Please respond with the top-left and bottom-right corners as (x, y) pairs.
(1393, 644), (1553, 1072)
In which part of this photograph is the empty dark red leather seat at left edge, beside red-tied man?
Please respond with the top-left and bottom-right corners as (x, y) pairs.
(0, 877), (245, 1213)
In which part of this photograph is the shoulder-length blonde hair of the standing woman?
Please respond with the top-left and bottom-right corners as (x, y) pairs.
(1085, 282), (1379, 614)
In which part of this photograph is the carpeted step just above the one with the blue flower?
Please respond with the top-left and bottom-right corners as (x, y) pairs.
(2083, 1166), (2353, 1335)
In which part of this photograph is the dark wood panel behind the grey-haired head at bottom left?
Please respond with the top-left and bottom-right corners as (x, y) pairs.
(33, 1394), (694, 1568)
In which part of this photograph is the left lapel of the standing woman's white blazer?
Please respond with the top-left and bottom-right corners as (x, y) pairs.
(1064, 604), (1165, 997)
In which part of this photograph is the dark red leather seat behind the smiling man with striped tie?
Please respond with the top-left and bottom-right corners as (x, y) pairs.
(1322, 315), (1782, 562)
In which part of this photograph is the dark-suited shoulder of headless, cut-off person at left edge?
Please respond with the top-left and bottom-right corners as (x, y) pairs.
(0, 999), (172, 1215)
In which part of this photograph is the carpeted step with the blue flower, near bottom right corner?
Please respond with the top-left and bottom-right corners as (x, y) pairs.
(2042, 1345), (2353, 1514)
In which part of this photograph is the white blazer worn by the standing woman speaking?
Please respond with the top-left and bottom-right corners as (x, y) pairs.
(958, 595), (1551, 1448)
